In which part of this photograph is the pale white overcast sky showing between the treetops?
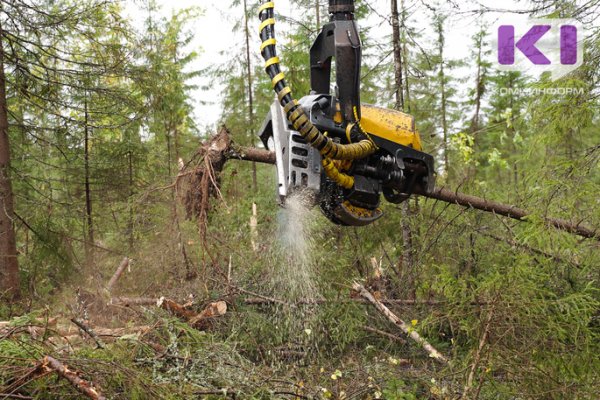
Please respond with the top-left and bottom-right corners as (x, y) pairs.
(120, 0), (592, 134)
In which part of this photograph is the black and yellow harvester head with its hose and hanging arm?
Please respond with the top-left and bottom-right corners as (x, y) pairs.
(259, 0), (435, 226)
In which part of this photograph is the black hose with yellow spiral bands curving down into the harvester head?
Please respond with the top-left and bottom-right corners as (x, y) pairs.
(258, 1), (377, 164)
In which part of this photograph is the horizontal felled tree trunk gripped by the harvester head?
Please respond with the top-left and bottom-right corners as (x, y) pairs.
(227, 147), (600, 240)
